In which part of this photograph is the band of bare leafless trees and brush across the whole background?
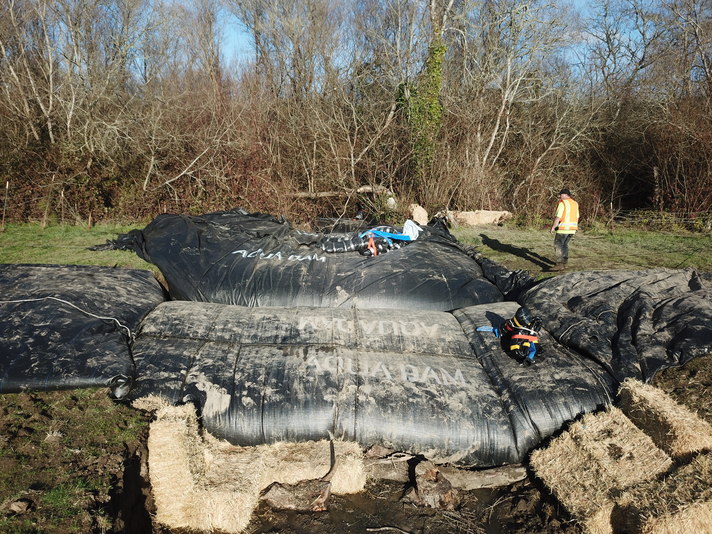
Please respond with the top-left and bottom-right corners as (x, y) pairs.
(0, 0), (712, 224)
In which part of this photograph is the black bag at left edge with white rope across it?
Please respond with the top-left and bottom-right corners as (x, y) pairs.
(0, 264), (164, 397)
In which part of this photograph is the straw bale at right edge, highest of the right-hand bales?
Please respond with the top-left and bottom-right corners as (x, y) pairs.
(618, 379), (712, 460)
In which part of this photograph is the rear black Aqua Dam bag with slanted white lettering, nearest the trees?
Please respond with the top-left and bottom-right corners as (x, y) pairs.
(97, 210), (502, 311)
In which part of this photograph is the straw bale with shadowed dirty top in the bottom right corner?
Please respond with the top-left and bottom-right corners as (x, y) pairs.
(612, 453), (712, 534)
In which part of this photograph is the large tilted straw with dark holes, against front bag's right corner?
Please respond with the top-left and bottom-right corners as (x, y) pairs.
(530, 408), (672, 528)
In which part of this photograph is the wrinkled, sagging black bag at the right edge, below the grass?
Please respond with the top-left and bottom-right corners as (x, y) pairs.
(521, 269), (712, 382)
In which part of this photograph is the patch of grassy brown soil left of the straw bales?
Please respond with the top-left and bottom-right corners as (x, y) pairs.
(0, 390), (151, 534)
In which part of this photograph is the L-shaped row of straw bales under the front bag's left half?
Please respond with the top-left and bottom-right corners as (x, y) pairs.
(148, 405), (366, 533)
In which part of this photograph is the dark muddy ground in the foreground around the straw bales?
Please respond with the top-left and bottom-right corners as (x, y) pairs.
(0, 355), (712, 534)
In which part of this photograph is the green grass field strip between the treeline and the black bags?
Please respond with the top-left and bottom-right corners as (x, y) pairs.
(0, 224), (712, 277)
